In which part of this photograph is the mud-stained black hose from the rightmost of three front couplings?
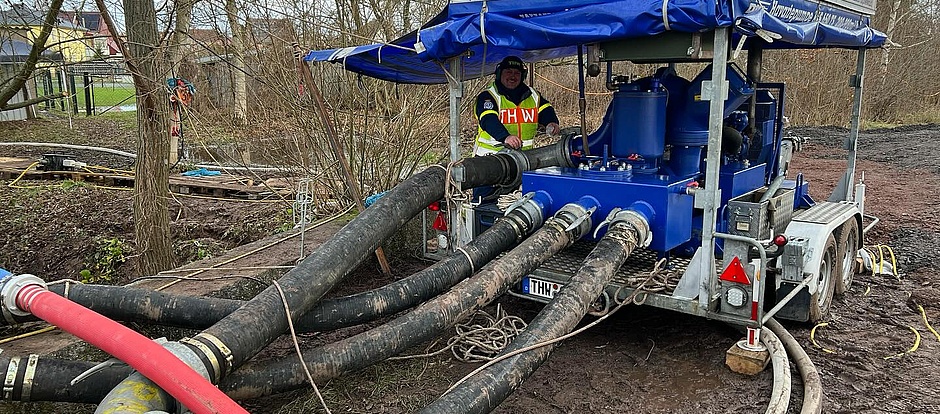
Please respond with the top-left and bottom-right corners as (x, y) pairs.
(421, 205), (651, 414)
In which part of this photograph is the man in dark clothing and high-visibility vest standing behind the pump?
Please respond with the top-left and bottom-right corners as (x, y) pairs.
(473, 56), (560, 156)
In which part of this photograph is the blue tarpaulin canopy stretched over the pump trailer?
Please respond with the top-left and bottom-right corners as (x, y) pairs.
(306, 0), (887, 84)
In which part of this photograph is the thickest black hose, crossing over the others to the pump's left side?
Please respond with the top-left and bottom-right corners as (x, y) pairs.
(185, 142), (570, 378)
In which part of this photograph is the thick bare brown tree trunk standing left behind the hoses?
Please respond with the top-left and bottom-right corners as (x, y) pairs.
(120, 0), (174, 275)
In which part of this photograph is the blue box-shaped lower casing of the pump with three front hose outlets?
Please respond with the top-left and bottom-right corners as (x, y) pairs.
(522, 167), (692, 253)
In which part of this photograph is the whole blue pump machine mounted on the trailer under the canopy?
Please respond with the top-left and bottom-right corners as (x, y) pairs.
(522, 64), (782, 255)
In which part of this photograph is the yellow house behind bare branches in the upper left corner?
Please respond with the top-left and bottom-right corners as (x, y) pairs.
(0, 4), (94, 63)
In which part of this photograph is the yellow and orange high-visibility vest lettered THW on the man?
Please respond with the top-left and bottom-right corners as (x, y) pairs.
(473, 83), (540, 156)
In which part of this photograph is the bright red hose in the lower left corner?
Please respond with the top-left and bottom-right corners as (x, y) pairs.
(16, 285), (248, 414)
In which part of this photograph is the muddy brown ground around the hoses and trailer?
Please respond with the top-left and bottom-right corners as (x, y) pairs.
(0, 118), (940, 414)
